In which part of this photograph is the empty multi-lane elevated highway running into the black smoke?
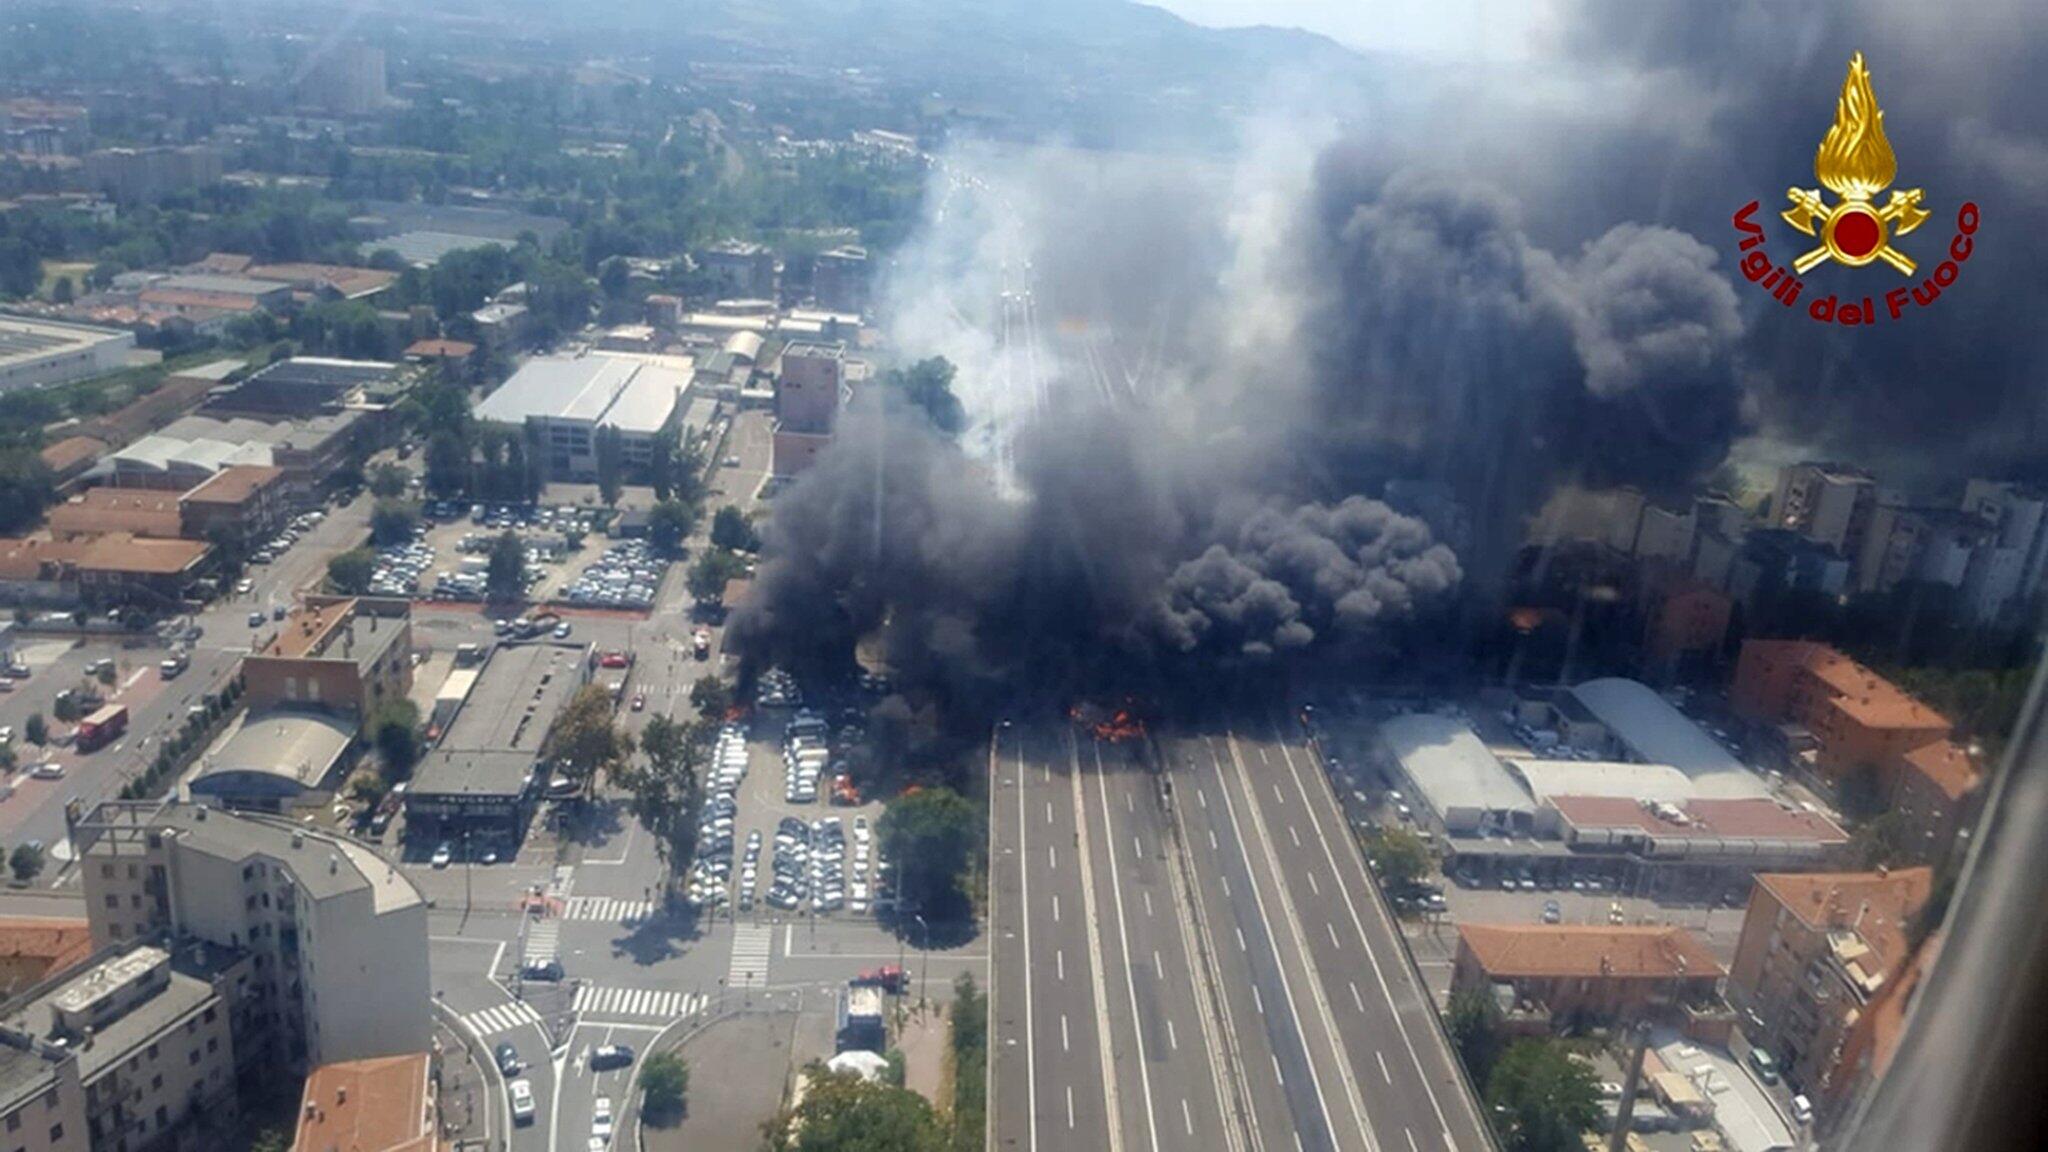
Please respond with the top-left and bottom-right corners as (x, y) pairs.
(991, 717), (1491, 1152)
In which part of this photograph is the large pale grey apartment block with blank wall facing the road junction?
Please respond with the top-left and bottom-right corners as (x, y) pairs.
(72, 801), (432, 1068)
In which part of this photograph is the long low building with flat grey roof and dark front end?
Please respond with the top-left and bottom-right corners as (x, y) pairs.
(406, 644), (590, 847)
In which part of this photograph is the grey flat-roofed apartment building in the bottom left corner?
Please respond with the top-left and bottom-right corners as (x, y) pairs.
(0, 939), (252, 1152)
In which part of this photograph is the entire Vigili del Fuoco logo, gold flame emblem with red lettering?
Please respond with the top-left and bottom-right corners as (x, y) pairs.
(1733, 53), (1978, 326)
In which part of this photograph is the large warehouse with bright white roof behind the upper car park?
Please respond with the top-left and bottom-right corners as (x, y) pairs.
(477, 353), (694, 484)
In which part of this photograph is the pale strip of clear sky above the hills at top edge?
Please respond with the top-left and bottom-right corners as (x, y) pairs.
(1147, 0), (1550, 59)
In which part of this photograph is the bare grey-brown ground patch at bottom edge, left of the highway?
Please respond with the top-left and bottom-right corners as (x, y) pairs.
(641, 1013), (797, 1152)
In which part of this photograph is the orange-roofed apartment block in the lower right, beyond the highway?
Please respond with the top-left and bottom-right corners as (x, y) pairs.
(1729, 867), (1933, 1097)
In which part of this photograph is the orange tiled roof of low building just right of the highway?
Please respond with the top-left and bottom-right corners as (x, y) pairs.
(1458, 924), (1726, 980)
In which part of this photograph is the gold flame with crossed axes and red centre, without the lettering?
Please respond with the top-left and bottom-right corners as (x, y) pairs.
(1780, 53), (1927, 277)
